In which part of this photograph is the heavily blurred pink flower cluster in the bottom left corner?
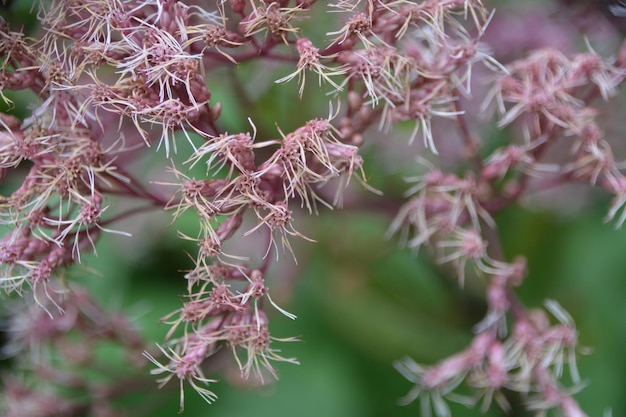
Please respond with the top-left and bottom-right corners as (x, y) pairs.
(2, 288), (144, 417)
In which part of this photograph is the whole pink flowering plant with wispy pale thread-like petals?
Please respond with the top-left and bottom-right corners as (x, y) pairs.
(0, 0), (626, 417)
